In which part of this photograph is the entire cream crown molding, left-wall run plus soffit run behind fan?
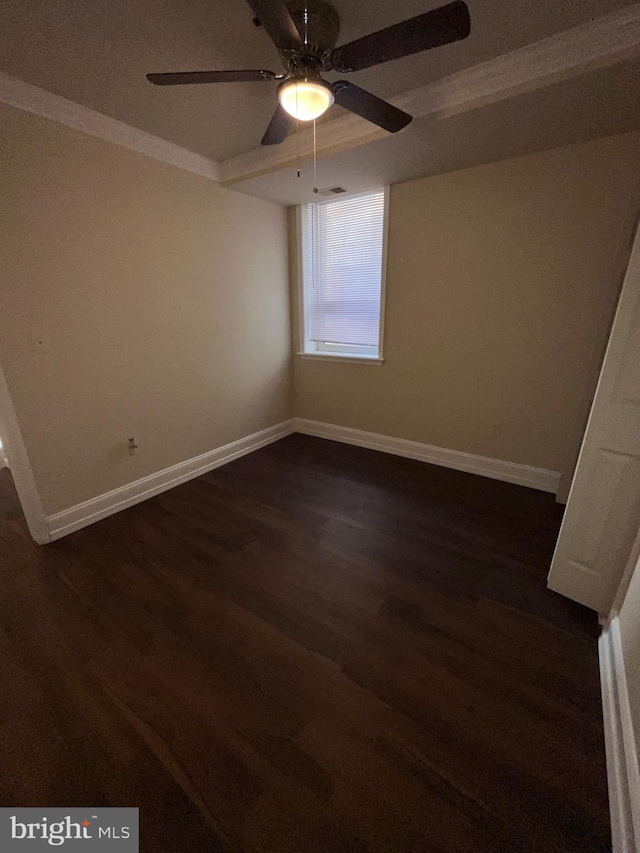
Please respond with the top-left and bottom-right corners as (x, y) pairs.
(0, 2), (640, 186)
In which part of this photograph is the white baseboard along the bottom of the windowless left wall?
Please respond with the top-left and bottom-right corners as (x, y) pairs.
(47, 419), (295, 540)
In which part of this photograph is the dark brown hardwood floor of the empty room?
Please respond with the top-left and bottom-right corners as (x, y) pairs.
(0, 435), (611, 853)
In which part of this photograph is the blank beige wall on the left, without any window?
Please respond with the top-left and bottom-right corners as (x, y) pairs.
(0, 106), (291, 513)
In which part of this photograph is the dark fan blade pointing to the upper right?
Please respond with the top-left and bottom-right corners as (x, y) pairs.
(331, 0), (471, 74)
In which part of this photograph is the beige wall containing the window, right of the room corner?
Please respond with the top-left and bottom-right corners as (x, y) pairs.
(290, 128), (640, 471)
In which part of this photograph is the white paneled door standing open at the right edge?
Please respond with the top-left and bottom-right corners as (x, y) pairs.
(549, 223), (640, 613)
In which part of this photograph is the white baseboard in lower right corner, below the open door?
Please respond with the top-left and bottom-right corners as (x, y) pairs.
(598, 617), (640, 853)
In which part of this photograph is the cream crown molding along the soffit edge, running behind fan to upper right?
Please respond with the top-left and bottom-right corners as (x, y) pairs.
(220, 3), (640, 185)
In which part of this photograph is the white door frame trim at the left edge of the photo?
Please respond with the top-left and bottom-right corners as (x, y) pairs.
(0, 365), (51, 545)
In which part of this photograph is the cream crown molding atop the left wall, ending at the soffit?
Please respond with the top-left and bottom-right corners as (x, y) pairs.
(0, 72), (220, 181)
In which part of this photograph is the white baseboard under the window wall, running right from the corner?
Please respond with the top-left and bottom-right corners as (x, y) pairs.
(294, 418), (560, 493)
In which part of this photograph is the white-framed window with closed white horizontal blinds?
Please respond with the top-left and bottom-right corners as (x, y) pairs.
(298, 190), (388, 363)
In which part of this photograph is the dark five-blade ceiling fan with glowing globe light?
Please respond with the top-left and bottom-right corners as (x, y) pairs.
(147, 0), (471, 145)
